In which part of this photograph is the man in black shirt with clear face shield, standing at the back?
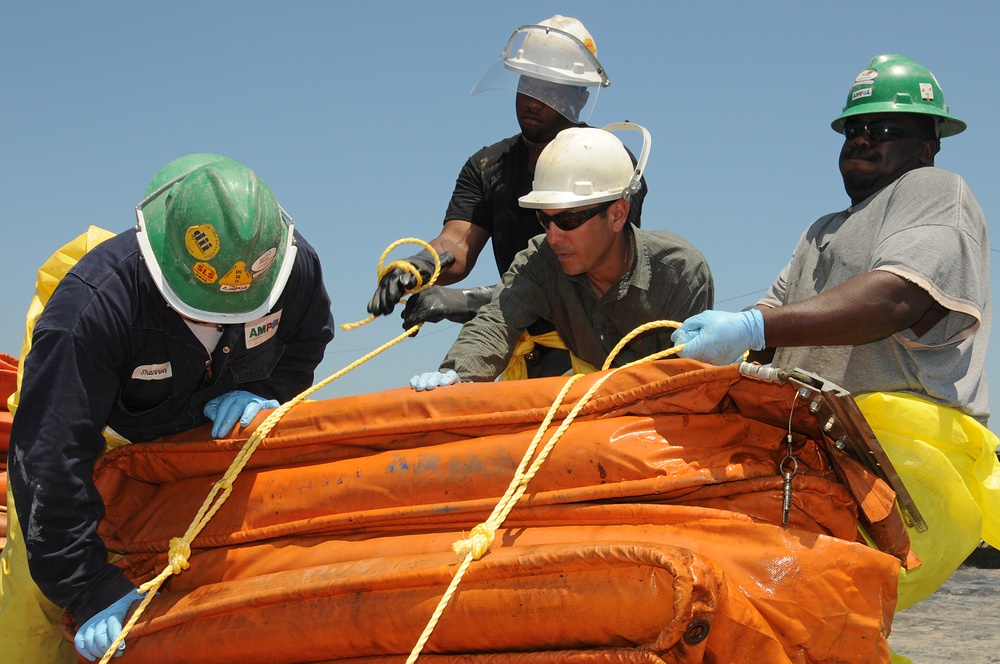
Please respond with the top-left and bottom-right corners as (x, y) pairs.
(368, 15), (646, 376)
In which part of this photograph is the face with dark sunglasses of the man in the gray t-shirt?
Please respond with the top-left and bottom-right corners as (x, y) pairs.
(840, 113), (938, 204)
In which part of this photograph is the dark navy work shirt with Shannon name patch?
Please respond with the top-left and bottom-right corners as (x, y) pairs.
(8, 230), (333, 624)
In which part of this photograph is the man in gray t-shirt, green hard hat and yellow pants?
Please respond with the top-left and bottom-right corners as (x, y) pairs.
(673, 55), (1000, 620)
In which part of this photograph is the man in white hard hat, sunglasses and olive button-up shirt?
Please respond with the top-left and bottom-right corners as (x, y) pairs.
(410, 123), (714, 391)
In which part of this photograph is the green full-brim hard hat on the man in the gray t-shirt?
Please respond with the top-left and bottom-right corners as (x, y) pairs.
(830, 55), (966, 138)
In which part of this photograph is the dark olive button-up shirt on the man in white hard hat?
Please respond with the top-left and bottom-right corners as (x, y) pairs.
(441, 226), (715, 381)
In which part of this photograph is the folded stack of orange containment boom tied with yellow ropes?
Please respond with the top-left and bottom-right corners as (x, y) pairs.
(88, 360), (907, 664)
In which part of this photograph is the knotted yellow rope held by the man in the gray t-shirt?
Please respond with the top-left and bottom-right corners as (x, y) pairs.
(406, 321), (684, 664)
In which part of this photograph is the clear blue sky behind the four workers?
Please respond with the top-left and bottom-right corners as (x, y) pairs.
(0, 0), (1000, 428)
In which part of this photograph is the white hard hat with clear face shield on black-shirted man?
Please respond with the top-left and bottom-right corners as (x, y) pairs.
(472, 14), (611, 122)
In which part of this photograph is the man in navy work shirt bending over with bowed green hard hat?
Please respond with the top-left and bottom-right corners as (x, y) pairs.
(0, 154), (333, 662)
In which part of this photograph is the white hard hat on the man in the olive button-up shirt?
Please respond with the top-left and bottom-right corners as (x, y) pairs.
(518, 122), (652, 210)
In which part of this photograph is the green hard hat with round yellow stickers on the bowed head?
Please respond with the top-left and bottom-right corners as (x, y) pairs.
(137, 159), (295, 323)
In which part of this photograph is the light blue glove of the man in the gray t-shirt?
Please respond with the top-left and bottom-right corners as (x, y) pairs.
(670, 309), (764, 365)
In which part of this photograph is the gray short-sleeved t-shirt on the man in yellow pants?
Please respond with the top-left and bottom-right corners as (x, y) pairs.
(759, 167), (992, 423)
